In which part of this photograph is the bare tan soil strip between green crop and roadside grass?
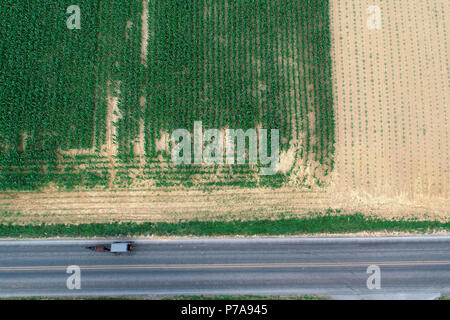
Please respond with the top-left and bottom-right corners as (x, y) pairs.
(0, 188), (450, 224)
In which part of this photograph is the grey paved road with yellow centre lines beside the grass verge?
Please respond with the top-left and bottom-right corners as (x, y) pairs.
(0, 236), (450, 299)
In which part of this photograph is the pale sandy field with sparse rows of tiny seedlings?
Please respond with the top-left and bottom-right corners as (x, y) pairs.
(331, 0), (450, 208)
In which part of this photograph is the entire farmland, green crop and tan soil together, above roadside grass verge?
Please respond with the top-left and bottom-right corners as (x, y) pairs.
(0, 0), (450, 226)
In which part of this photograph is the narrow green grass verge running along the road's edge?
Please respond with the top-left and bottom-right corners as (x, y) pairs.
(0, 211), (450, 238)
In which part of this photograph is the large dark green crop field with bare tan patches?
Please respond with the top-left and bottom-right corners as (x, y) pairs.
(0, 0), (334, 190)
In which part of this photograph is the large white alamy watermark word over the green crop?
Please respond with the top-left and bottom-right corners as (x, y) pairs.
(171, 121), (280, 175)
